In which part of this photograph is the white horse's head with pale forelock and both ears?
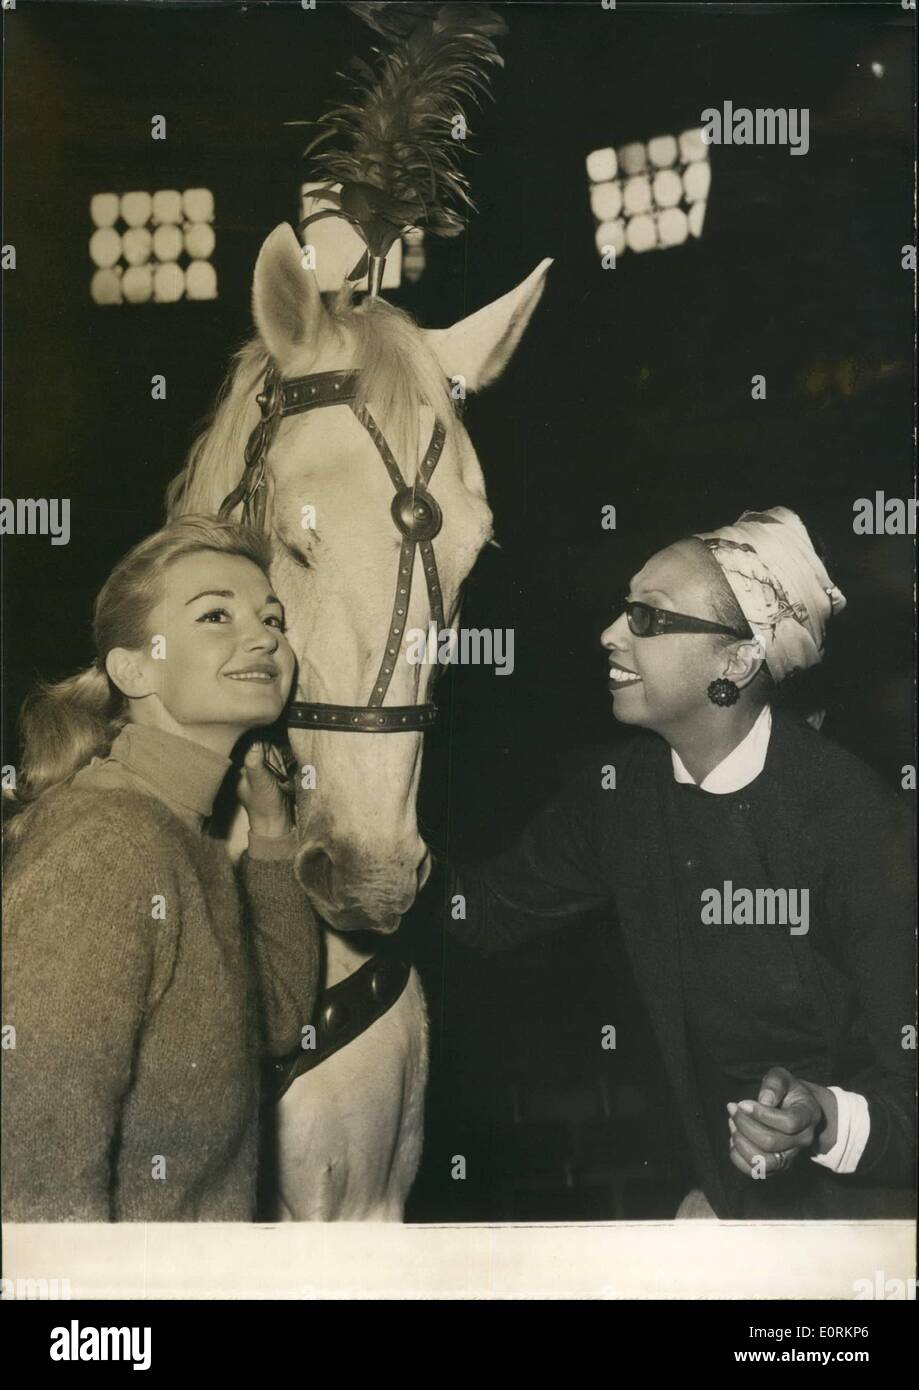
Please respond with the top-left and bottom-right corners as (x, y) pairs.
(171, 224), (551, 933)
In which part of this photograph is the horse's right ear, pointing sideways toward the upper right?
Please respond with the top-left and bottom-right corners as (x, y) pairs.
(424, 259), (552, 391)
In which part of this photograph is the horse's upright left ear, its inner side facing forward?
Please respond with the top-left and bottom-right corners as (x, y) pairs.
(252, 222), (328, 368)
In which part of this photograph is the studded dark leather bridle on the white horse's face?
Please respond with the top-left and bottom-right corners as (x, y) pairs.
(217, 367), (446, 734)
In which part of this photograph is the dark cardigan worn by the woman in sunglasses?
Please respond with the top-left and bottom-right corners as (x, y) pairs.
(449, 713), (915, 1219)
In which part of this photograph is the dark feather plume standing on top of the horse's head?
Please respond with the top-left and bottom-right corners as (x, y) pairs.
(298, 0), (506, 297)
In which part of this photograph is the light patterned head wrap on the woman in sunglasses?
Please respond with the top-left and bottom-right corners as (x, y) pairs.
(697, 507), (845, 682)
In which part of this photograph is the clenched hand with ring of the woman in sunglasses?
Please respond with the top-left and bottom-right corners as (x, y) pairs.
(727, 1066), (836, 1179)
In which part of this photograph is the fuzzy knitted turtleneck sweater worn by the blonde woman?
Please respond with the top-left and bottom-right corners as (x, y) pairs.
(1, 724), (318, 1222)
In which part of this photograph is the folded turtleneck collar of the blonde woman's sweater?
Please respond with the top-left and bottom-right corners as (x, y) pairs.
(107, 724), (229, 819)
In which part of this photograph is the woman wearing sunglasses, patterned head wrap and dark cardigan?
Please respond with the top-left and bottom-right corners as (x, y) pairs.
(450, 507), (915, 1219)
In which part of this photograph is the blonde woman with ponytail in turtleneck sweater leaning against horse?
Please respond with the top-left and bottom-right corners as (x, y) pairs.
(3, 516), (318, 1222)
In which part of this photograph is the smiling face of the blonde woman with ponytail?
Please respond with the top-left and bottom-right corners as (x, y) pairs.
(142, 550), (295, 737)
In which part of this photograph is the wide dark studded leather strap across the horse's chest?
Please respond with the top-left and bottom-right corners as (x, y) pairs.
(264, 954), (412, 1101)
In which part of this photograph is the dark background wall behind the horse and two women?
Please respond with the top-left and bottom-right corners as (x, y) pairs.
(3, 0), (915, 1220)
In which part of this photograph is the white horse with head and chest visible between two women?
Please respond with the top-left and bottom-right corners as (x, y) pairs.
(171, 224), (552, 1220)
